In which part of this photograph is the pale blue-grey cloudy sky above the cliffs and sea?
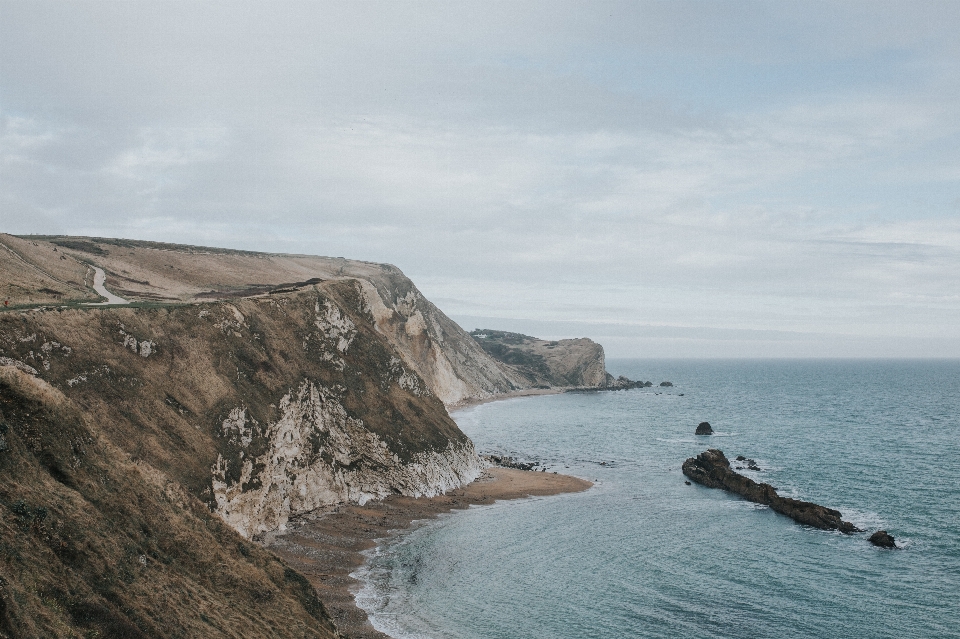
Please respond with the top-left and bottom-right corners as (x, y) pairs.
(0, 0), (960, 358)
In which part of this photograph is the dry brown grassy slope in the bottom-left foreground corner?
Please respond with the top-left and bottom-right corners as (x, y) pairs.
(0, 364), (339, 639)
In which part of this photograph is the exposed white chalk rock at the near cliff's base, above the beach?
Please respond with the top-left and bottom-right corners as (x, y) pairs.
(213, 380), (482, 537)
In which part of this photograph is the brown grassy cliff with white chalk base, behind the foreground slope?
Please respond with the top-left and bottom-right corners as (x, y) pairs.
(0, 279), (481, 537)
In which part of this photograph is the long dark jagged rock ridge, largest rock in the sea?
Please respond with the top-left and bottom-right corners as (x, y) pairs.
(681, 448), (862, 535)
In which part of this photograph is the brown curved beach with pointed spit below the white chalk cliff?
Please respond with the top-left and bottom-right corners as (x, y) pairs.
(264, 467), (593, 639)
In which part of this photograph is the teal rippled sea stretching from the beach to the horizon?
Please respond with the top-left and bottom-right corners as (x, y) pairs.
(358, 360), (960, 639)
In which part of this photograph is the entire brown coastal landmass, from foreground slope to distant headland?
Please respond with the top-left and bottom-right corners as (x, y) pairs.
(0, 234), (633, 637)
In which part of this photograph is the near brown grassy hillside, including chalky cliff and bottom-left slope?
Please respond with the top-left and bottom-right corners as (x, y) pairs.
(0, 280), (480, 637)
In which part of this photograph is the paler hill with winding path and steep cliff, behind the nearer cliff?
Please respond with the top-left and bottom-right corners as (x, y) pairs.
(0, 234), (527, 406)
